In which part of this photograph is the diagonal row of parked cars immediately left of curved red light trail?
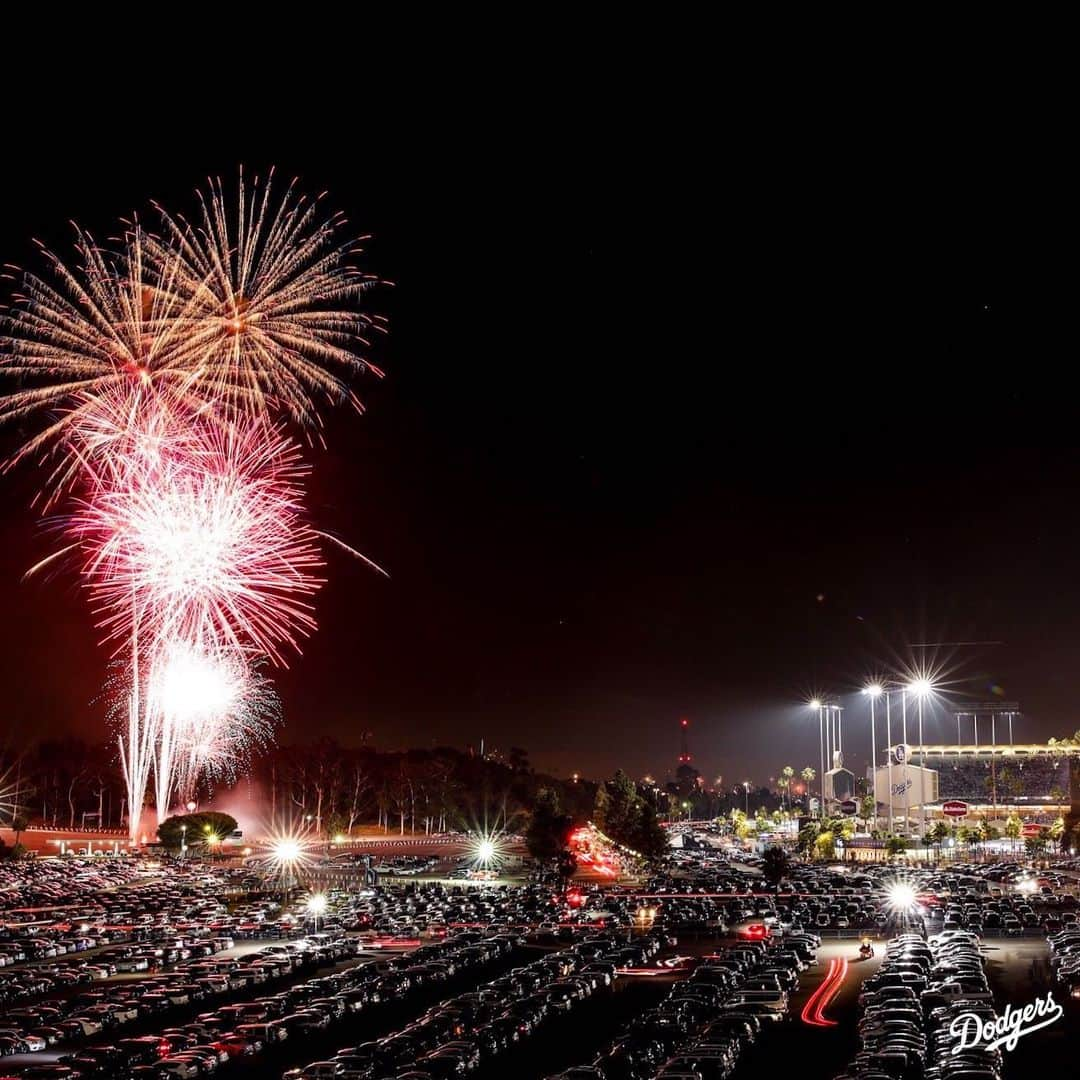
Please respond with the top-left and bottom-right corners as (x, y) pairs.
(549, 932), (821, 1080)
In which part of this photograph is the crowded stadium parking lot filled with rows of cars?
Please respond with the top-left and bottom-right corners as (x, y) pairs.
(0, 850), (1080, 1080)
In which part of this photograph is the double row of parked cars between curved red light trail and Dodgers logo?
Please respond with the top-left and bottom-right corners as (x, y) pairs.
(837, 930), (1001, 1080)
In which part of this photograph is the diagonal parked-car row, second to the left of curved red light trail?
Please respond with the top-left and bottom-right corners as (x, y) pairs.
(284, 929), (660, 1080)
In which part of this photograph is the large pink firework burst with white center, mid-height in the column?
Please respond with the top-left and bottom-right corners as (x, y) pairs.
(68, 412), (323, 664)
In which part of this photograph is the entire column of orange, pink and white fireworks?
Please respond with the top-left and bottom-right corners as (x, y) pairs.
(0, 175), (384, 838)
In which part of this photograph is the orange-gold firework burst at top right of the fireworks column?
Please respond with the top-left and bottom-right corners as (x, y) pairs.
(148, 166), (386, 428)
